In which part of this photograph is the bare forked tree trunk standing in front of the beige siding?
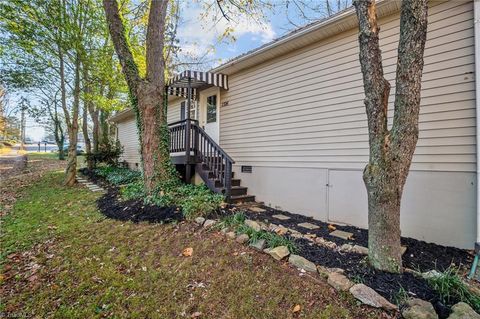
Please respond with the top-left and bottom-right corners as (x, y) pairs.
(354, 0), (428, 272)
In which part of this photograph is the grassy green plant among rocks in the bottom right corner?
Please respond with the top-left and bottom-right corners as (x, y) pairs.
(428, 267), (480, 312)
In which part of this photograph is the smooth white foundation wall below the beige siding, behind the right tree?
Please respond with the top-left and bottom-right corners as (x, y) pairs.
(234, 166), (476, 249)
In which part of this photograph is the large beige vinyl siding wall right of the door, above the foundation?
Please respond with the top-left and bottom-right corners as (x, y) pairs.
(220, 1), (475, 172)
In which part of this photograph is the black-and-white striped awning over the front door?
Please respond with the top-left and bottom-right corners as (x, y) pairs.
(167, 70), (228, 98)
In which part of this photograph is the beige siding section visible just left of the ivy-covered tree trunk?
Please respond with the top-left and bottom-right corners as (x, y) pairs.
(117, 116), (140, 168)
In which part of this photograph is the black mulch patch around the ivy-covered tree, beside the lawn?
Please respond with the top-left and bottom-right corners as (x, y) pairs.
(81, 169), (184, 223)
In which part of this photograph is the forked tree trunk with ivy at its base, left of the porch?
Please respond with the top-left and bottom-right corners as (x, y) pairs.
(103, 0), (177, 193)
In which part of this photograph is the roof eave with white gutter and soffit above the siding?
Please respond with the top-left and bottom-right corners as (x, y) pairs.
(110, 0), (404, 122)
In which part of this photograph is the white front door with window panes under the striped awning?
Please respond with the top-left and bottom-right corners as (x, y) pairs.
(200, 88), (220, 144)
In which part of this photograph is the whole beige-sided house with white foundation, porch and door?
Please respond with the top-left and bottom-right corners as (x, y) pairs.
(112, 1), (480, 248)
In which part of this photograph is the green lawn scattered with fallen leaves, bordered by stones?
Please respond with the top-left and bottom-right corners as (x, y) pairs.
(0, 172), (388, 318)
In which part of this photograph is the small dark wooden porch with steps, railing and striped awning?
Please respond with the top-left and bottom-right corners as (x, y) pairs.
(166, 71), (255, 203)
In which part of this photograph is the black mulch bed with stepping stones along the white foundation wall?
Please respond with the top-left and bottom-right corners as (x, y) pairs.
(246, 206), (473, 318)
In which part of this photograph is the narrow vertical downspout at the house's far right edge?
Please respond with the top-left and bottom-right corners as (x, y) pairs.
(468, 0), (480, 279)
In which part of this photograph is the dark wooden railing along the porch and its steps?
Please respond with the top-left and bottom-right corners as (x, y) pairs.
(169, 119), (235, 200)
